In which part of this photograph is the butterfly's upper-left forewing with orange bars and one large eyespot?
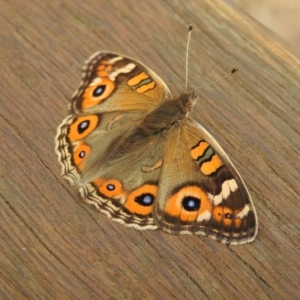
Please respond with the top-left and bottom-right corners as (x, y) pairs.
(71, 52), (171, 113)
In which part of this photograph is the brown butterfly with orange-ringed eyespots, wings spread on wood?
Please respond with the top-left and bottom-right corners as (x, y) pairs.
(55, 47), (257, 245)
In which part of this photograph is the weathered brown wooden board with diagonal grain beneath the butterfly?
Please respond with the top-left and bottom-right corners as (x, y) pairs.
(0, 0), (300, 299)
